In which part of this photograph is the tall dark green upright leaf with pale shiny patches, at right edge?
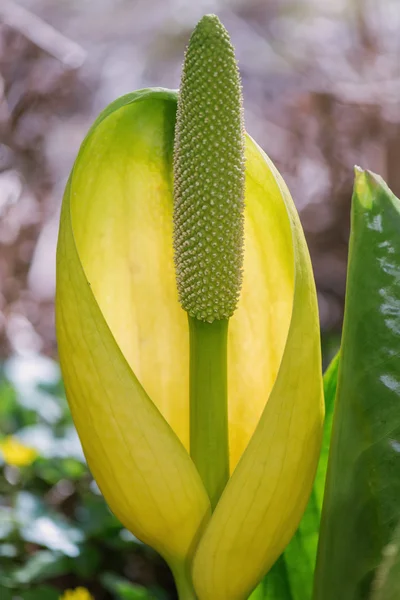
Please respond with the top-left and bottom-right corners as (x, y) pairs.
(314, 171), (400, 600)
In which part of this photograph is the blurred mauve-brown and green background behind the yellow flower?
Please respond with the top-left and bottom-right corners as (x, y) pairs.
(0, 0), (400, 600)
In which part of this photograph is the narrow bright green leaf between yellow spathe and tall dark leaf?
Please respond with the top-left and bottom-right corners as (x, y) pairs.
(251, 354), (339, 600)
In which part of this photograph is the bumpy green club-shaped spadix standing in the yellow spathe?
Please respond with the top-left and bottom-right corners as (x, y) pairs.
(174, 15), (244, 322)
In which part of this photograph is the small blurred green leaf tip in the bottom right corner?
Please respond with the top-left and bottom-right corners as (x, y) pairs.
(371, 525), (400, 600)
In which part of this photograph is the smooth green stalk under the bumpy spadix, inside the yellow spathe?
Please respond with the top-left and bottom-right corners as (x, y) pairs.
(189, 317), (229, 509)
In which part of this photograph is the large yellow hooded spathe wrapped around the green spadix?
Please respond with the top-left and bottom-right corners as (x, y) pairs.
(56, 17), (323, 600)
